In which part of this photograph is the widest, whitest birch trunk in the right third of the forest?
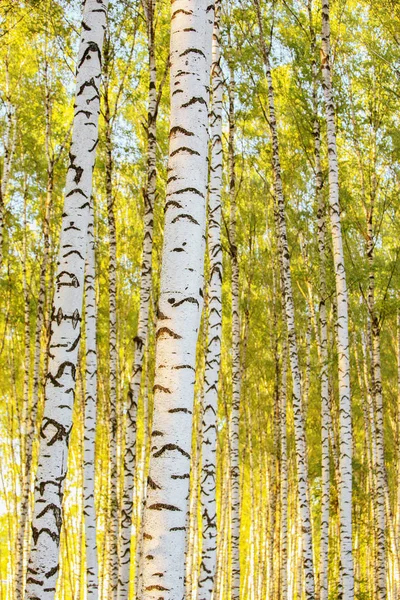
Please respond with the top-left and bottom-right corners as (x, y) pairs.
(321, 0), (354, 600)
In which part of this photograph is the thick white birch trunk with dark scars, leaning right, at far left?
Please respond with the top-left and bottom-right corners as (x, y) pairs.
(26, 0), (107, 600)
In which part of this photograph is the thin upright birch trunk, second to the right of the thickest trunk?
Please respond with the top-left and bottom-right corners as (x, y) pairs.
(228, 67), (241, 600)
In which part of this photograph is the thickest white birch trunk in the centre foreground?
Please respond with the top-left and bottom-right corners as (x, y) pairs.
(143, 0), (214, 600)
